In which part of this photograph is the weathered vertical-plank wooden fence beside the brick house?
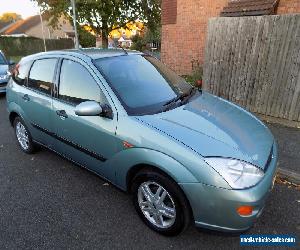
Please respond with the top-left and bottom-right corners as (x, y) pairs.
(203, 14), (300, 122)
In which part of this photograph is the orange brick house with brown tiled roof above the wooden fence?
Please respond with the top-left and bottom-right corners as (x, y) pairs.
(161, 0), (300, 75)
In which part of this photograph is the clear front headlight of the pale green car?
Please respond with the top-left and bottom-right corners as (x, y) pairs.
(205, 157), (264, 189)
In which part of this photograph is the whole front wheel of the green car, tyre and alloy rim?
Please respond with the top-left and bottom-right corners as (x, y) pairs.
(131, 169), (191, 236)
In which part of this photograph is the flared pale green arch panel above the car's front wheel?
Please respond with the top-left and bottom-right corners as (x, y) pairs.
(110, 148), (198, 190)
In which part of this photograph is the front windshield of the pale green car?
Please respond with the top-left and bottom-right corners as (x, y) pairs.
(94, 55), (192, 115)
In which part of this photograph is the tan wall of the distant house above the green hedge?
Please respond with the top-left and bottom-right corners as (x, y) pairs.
(26, 18), (73, 39)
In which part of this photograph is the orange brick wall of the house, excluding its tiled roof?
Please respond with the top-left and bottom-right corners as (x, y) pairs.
(161, 0), (300, 75)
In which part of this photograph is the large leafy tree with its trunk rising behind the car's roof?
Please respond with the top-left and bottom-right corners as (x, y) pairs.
(33, 0), (161, 47)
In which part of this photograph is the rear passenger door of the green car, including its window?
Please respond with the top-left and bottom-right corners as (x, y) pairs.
(19, 58), (58, 147)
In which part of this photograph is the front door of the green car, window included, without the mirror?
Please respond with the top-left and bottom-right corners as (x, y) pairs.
(53, 59), (117, 179)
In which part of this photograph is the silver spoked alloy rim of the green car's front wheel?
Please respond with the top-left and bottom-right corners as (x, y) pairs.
(138, 181), (176, 228)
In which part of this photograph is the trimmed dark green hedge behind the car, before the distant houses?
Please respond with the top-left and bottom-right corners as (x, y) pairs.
(0, 36), (74, 57)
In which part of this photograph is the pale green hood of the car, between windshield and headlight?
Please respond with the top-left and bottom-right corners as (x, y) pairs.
(136, 92), (274, 169)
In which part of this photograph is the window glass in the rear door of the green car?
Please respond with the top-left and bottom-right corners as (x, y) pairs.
(28, 58), (57, 95)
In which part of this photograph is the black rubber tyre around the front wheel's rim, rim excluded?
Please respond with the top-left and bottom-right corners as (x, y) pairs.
(131, 171), (189, 236)
